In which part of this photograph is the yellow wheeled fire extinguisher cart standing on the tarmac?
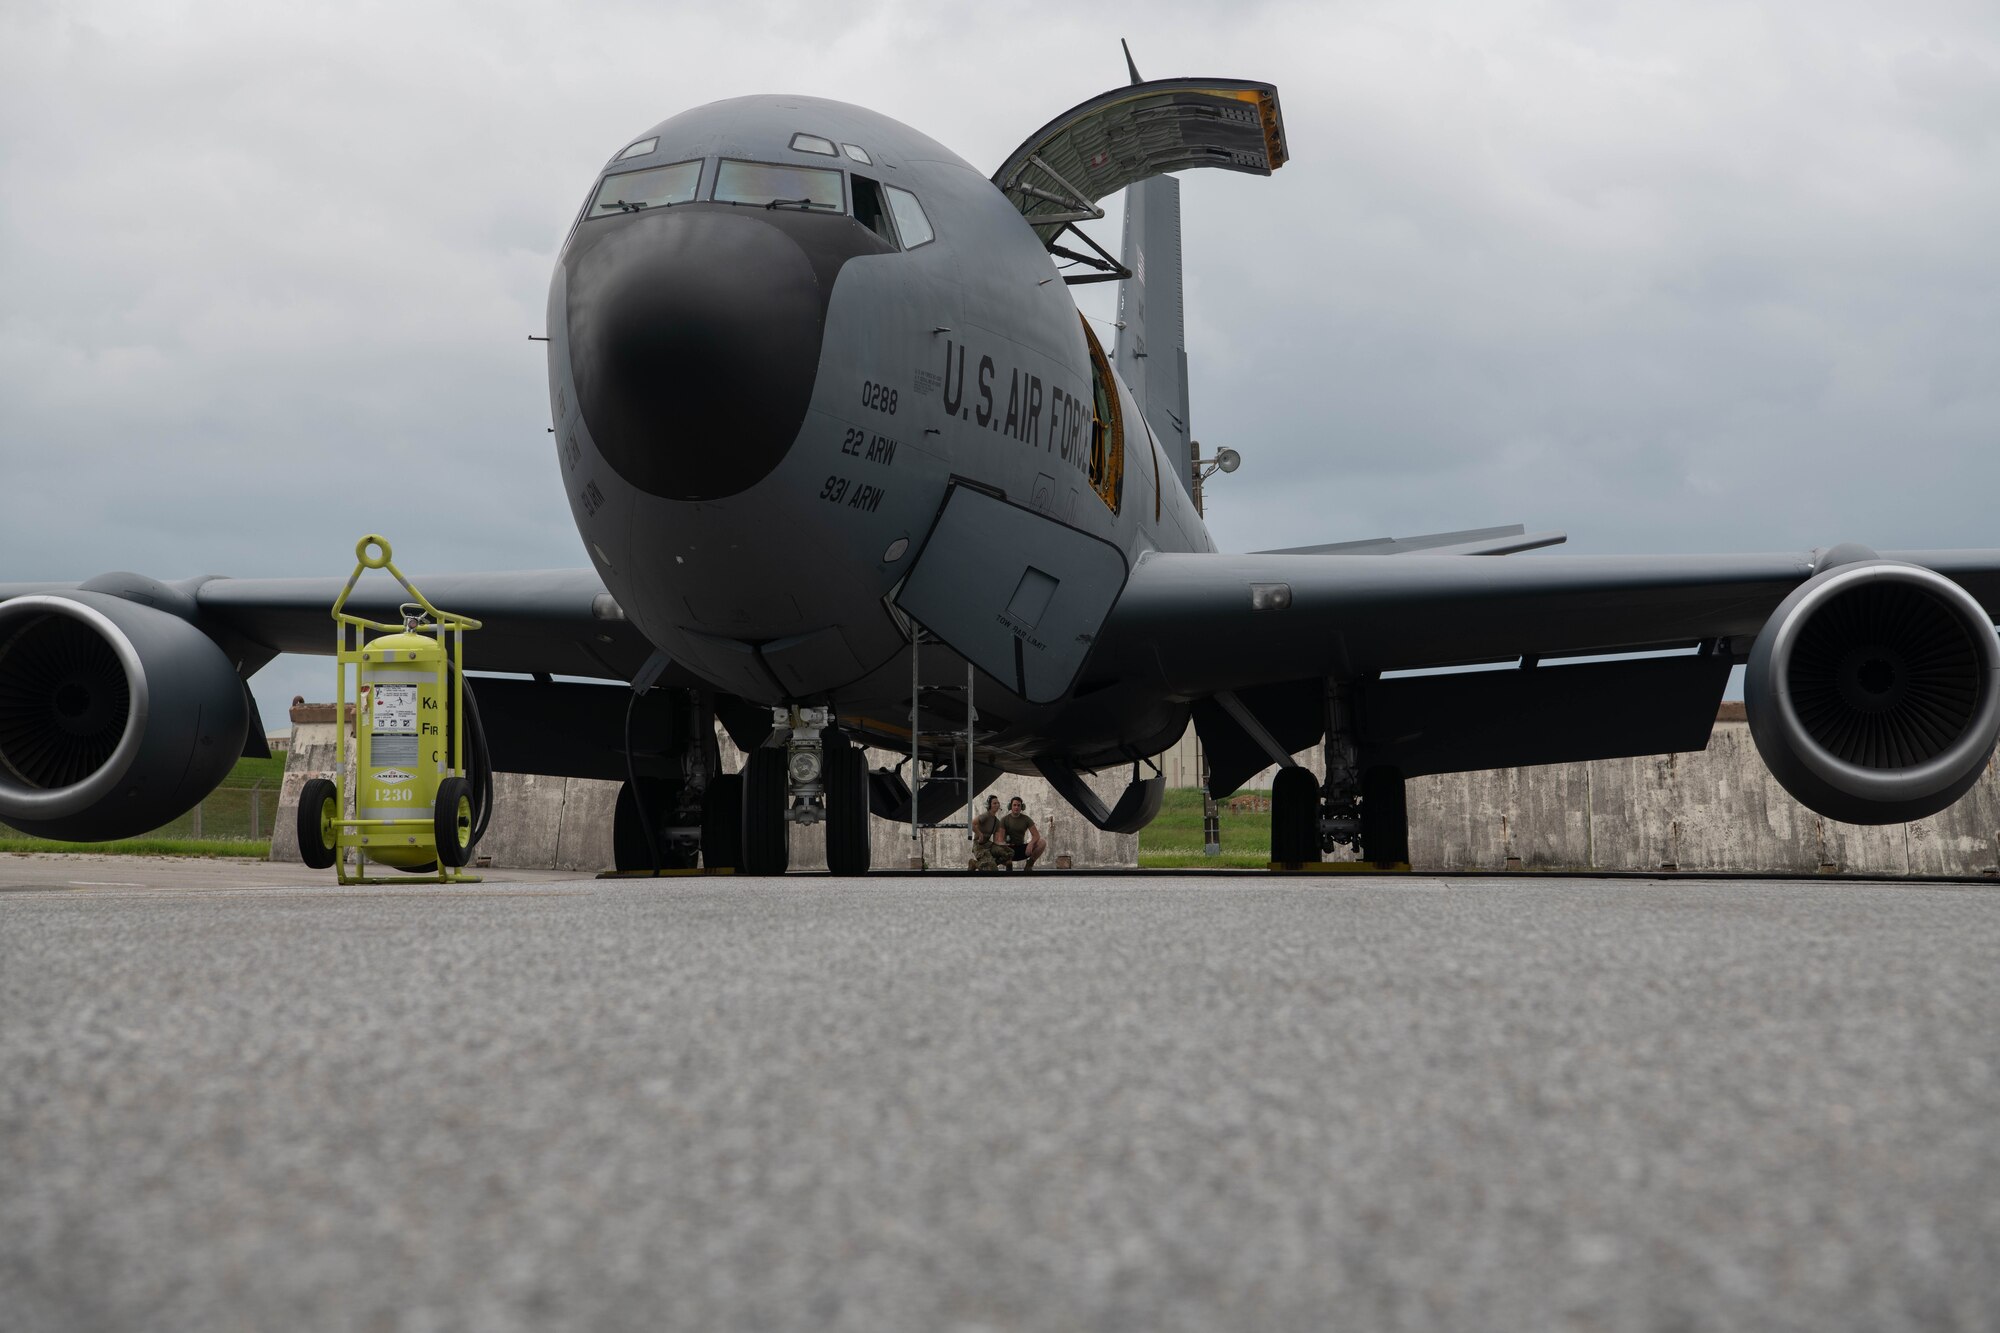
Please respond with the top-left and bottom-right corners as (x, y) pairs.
(298, 532), (480, 885)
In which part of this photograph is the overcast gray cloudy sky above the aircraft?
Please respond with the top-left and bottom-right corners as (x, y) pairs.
(0, 0), (2000, 727)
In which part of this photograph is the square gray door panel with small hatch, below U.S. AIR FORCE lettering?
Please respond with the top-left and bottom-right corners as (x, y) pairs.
(896, 484), (1126, 703)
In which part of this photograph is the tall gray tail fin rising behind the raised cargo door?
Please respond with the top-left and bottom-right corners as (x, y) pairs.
(1114, 176), (1194, 486)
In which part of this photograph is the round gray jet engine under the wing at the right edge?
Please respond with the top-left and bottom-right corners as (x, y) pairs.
(1744, 548), (2000, 825)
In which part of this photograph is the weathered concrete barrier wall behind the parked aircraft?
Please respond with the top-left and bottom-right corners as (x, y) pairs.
(272, 705), (2000, 875)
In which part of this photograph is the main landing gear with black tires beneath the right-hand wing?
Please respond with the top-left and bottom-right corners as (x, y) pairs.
(1270, 681), (1410, 871)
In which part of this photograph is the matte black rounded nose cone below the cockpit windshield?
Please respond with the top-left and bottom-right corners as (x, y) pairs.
(566, 208), (832, 500)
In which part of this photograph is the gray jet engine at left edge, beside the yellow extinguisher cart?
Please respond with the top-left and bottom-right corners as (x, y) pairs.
(0, 590), (250, 841)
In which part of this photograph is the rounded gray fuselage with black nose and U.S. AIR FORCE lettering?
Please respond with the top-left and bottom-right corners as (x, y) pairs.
(548, 96), (1214, 763)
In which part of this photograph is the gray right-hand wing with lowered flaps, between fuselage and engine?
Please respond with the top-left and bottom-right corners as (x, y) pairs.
(1078, 550), (2000, 793)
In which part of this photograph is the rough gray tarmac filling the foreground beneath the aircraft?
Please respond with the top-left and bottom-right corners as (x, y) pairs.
(0, 857), (2000, 1333)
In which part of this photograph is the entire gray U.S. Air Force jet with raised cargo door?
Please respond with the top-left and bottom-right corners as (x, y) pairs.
(11, 70), (2000, 873)
